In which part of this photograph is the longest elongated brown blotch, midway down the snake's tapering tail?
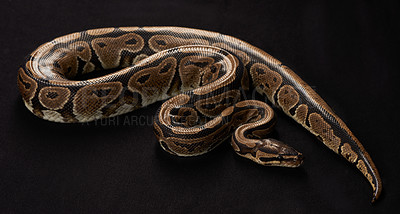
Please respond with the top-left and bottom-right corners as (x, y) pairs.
(308, 113), (341, 153)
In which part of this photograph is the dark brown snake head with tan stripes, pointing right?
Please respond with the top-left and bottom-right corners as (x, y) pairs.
(252, 138), (304, 167)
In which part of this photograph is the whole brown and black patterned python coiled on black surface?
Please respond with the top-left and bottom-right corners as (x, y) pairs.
(17, 27), (382, 201)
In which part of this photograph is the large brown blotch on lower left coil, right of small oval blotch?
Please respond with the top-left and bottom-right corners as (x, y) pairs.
(73, 82), (122, 121)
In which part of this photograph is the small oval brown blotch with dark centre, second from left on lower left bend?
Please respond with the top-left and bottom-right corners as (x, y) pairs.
(38, 86), (71, 110)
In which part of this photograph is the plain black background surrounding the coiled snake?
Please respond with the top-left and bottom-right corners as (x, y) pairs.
(0, 0), (400, 213)
